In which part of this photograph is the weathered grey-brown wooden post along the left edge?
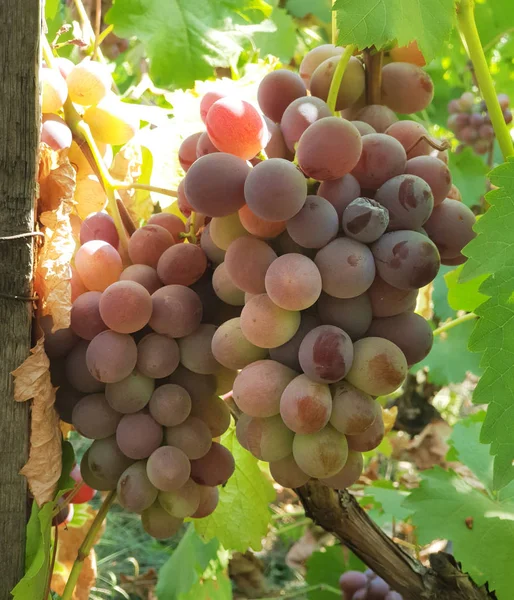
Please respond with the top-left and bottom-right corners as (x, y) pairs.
(0, 0), (41, 600)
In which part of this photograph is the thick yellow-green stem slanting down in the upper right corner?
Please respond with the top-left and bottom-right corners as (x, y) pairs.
(457, 0), (514, 160)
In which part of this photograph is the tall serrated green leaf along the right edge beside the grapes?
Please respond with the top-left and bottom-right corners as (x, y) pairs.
(457, 158), (514, 489)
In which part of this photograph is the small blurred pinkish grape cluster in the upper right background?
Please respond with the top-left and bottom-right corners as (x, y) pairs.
(447, 92), (512, 154)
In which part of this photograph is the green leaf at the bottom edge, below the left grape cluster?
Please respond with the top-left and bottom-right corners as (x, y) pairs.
(156, 525), (232, 600)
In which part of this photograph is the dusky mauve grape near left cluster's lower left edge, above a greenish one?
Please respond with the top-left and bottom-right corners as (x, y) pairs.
(72, 394), (121, 440)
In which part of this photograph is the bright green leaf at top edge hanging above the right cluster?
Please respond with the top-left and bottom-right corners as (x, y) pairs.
(334, 0), (455, 62)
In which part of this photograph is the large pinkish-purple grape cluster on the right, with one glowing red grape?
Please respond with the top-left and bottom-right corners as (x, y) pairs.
(170, 45), (475, 489)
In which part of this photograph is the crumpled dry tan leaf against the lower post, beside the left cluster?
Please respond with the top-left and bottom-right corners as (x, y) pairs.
(12, 337), (61, 506)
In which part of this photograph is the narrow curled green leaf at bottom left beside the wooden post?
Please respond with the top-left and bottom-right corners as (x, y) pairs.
(11, 502), (55, 600)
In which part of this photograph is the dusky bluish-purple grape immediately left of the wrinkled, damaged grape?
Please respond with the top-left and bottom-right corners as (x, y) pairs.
(287, 196), (339, 248)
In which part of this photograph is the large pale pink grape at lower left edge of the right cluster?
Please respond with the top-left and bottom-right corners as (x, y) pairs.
(233, 360), (296, 417)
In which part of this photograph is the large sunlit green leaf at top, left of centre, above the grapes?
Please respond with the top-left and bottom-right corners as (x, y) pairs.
(105, 0), (271, 88)
